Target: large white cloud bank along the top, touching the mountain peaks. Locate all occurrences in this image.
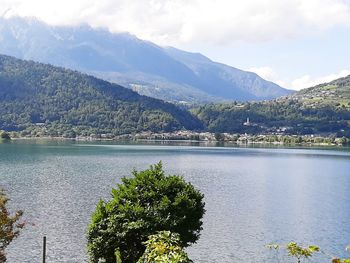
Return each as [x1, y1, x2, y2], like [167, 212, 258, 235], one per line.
[0, 0, 350, 44]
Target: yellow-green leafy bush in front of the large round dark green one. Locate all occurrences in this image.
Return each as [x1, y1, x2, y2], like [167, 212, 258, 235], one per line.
[138, 231, 192, 263]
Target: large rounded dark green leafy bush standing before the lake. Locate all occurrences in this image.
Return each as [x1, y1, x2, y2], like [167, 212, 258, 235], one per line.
[88, 162, 205, 263]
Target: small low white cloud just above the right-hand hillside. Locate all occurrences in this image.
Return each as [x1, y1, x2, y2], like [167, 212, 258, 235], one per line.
[291, 69, 350, 90]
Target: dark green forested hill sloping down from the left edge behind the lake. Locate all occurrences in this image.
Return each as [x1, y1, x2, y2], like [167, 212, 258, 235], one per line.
[0, 55, 202, 137]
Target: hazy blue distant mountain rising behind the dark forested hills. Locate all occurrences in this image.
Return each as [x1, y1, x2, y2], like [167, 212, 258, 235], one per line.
[0, 17, 291, 104]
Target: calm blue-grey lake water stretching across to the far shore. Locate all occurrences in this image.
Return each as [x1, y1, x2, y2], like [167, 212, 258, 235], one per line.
[0, 141, 350, 263]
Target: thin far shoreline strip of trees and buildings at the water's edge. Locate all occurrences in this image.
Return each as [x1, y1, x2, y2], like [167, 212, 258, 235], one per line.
[6, 131, 350, 147]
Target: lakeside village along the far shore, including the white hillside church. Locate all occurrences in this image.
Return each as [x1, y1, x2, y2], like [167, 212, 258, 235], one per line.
[0, 118, 350, 146]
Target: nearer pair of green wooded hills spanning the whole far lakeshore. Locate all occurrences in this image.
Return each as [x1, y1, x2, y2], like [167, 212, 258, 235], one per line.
[0, 52, 350, 137]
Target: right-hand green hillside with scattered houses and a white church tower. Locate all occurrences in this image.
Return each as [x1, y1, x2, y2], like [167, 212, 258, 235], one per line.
[192, 76, 350, 137]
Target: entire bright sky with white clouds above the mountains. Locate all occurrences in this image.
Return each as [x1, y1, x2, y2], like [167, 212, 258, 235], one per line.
[0, 0, 350, 90]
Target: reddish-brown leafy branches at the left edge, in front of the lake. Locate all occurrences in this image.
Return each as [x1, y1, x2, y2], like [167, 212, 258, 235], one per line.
[0, 189, 24, 262]
